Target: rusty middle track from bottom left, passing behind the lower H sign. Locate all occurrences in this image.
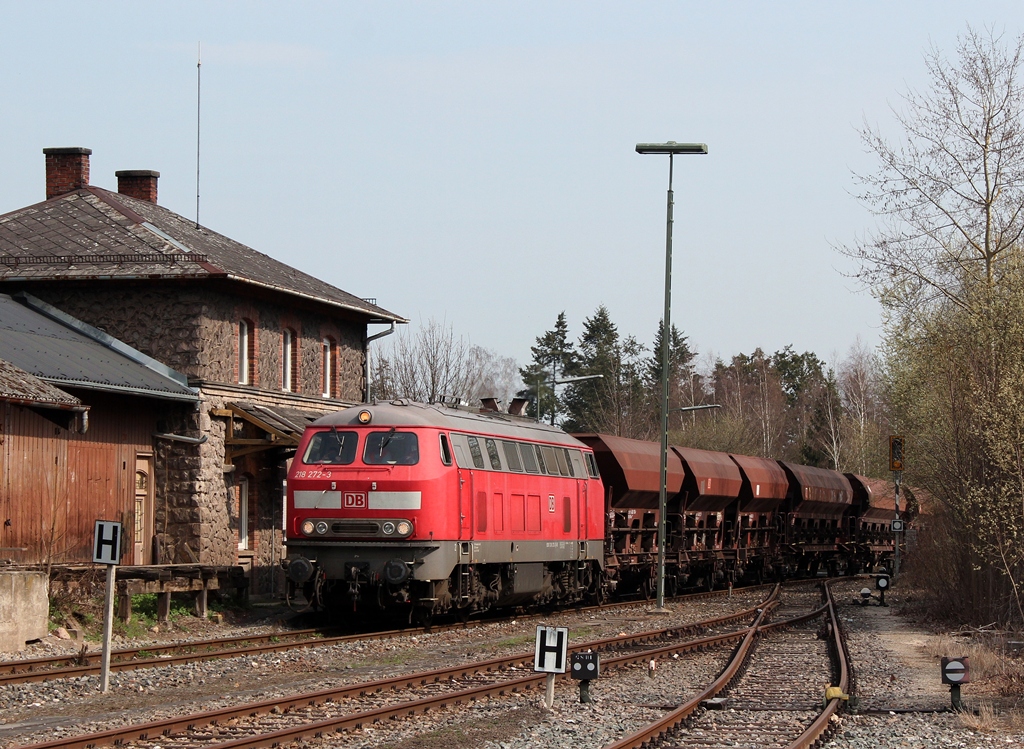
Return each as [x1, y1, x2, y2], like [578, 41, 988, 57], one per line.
[9, 587, 778, 749]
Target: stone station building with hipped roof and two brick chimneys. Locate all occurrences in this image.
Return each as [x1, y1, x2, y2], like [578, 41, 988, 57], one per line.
[0, 148, 407, 593]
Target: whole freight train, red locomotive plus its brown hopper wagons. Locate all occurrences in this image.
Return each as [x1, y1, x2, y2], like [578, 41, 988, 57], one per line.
[283, 400, 894, 622]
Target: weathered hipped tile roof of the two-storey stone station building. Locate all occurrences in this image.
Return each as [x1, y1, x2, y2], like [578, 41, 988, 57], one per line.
[0, 186, 406, 322]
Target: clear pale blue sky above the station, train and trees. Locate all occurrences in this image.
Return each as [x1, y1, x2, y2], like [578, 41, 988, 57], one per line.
[0, 0, 1024, 370]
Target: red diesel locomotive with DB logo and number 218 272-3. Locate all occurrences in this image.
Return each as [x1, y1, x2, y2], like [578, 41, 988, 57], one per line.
[286, 401, 604, 621]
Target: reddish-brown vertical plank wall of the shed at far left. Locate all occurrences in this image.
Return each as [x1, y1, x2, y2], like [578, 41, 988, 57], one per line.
[0, 390, 157, 565]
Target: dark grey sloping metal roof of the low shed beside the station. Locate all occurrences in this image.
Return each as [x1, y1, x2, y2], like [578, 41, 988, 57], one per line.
[0, 294, 199, 401]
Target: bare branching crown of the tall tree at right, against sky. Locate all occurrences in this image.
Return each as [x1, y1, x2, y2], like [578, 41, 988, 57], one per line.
[840, 28, 1024, 317]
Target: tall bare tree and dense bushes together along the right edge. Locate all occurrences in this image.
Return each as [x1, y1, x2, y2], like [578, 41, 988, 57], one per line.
[844, 28, 1024, 627]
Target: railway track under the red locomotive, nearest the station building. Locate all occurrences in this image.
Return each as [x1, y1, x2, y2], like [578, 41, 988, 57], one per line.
[0, 586, 770, 686]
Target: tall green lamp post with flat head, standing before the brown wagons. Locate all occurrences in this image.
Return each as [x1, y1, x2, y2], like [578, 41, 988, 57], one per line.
[637, 140, 708, 609]
